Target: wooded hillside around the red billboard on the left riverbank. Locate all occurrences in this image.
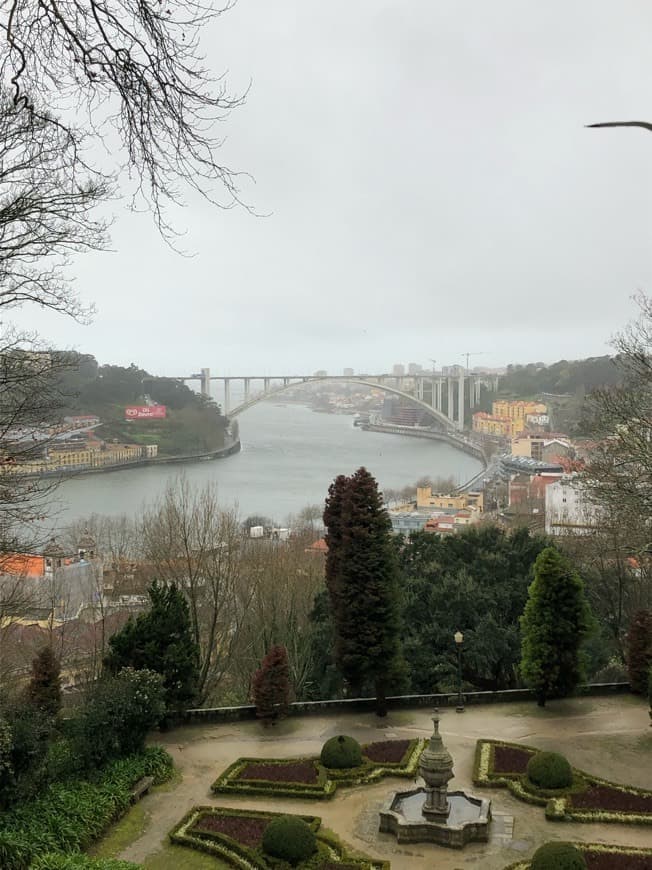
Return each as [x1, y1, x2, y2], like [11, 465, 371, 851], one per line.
[58, 354, 227, 456]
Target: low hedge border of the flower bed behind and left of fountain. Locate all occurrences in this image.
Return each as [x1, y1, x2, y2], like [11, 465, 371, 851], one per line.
[211, 738, 427, 800]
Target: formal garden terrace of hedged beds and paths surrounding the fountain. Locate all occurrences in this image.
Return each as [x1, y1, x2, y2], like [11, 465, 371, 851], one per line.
[62, 695, 652, 870]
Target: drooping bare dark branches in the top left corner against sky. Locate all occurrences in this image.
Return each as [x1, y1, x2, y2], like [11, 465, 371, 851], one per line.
[0, 0, 243, 227]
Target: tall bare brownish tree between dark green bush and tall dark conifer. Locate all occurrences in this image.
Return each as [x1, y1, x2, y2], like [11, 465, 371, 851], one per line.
[140, 477, 254, 703]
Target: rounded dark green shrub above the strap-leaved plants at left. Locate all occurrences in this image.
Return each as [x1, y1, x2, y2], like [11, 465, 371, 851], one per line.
[70, 668, 165, 770]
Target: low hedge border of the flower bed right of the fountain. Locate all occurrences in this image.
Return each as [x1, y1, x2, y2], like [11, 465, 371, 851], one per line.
[473, 740, 652, 828]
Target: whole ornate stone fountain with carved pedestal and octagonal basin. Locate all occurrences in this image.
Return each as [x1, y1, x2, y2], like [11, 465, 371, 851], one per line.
[380, 710, 491, 849]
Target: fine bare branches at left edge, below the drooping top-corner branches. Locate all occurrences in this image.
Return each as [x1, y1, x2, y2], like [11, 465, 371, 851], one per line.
[0, 93, 111, 319]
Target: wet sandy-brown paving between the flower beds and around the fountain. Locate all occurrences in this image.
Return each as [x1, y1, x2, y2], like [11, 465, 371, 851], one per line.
[119, 696, 652, 870]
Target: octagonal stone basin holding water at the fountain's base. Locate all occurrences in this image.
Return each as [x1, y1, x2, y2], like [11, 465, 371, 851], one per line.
[380, 788, 491, 849]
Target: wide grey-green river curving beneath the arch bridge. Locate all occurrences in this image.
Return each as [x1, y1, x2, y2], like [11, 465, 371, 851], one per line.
[49, 401, 481, 527]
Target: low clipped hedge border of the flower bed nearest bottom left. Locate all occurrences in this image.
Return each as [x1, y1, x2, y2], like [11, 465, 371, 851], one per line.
[168, 806, 390, 870]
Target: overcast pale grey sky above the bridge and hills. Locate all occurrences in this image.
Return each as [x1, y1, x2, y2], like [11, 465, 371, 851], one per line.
[17, 0, 652, 374]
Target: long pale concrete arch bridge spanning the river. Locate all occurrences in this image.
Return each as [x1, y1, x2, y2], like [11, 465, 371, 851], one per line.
[169, 366, 495, 432]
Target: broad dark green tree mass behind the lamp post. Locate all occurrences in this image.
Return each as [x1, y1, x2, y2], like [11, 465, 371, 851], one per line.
[399, 525, 547, 693]
